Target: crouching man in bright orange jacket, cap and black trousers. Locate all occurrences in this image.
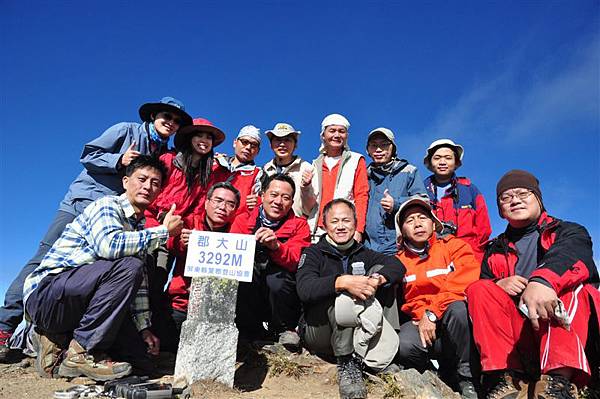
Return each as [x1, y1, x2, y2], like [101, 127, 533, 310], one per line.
[396, 197, 480, 399]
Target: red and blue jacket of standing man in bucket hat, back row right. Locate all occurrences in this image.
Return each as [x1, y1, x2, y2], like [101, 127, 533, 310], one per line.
[424, 175, 492, 261]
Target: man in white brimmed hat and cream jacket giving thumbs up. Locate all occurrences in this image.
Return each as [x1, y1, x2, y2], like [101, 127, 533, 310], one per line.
[263, 123, 319, 216]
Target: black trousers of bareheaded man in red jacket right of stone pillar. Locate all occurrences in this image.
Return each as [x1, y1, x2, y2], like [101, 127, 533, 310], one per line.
[235, 265, 301, 334]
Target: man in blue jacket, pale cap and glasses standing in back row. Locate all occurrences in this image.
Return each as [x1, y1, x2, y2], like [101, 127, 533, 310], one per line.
[365, 127, 427, 255]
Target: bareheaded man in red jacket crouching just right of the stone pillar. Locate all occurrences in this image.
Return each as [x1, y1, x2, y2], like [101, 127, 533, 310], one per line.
[231, 174, 310, 350]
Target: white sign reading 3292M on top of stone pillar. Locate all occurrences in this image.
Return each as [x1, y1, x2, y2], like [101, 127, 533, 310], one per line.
[184, 230, 256, 282]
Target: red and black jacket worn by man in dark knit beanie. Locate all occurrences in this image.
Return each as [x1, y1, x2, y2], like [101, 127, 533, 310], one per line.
[481, 212, 598, 296]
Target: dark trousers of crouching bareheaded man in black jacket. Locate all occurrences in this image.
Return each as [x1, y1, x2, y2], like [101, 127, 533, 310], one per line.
[300, 298, 354, 357]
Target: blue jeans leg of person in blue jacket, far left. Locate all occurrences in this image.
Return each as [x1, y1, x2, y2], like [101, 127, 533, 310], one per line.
[0, 211, 75, 333]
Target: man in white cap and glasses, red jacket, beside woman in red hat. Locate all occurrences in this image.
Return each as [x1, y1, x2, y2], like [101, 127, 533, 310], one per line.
[217, 125, 262, 215]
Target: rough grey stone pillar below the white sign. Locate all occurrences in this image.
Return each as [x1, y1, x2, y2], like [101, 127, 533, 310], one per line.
[175, 277, 238, 387]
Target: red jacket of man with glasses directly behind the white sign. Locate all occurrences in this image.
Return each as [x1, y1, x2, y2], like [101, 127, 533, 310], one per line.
[167, 212, 230, 312]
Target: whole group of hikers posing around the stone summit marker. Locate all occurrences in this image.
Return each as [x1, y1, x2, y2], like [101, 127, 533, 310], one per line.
[0, 97, 600, 398]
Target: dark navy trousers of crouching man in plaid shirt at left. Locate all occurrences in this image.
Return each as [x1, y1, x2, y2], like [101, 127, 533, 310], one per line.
[26, 257, 145, 352]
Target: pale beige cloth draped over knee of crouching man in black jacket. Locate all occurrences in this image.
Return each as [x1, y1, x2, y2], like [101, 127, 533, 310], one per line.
[335, 293, 400, 370]
